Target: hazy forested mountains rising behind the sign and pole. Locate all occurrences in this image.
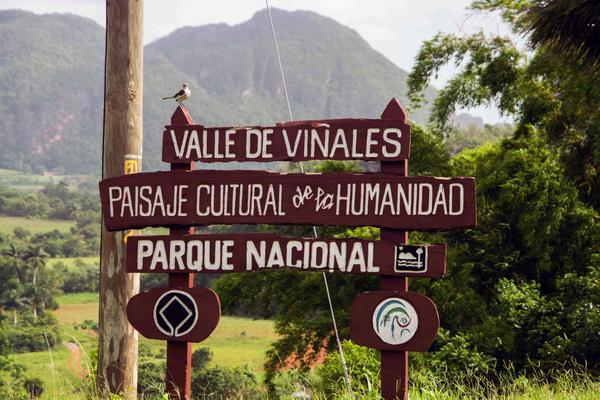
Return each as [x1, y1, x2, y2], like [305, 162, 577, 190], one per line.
[0, 10, 434, 173]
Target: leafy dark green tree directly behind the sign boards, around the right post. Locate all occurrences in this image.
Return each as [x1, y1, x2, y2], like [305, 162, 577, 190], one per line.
[215, 124, 450, 382]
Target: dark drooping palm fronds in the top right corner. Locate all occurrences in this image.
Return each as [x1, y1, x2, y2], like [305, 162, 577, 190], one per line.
[522, 0, 600, 66]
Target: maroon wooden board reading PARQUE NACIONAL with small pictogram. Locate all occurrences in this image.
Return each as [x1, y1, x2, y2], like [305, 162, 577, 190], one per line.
[125, 233, 446, 278]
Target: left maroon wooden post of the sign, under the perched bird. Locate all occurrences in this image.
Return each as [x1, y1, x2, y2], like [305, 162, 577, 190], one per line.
[165, 106, 195, 400]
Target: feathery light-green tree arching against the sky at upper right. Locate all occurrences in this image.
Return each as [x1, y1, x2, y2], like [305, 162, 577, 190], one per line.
[408, 0, 600, 209]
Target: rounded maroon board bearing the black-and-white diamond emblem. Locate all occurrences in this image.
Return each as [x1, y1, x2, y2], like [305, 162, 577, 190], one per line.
[127, 288, 221, 342]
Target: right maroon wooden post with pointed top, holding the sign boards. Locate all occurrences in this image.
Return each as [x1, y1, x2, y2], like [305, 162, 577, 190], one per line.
[380, 99, 408, 400]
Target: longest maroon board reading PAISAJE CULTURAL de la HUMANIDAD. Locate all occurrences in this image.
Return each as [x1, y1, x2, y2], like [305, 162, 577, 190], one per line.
[100, 171, 476, 231]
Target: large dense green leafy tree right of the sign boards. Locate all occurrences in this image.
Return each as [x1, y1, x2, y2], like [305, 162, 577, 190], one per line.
[436, 129, 600, 371]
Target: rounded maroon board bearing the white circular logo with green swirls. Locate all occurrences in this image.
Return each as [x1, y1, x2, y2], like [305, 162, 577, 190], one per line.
[350, 291, 440, 351]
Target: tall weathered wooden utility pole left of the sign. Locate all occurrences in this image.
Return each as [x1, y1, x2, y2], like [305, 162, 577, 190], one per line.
[98, 0, 144, 399]
